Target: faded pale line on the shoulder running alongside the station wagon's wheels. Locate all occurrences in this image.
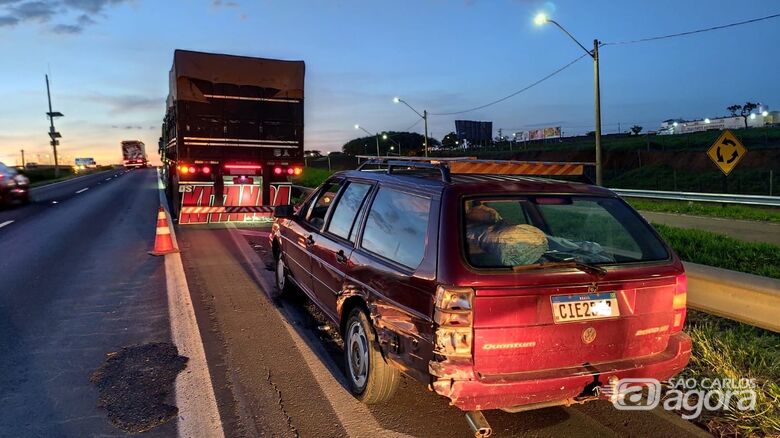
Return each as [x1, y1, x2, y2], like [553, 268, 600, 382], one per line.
[225, 223, 411, 438]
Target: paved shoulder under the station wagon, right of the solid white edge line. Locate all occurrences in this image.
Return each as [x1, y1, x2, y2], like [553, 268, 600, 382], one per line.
[178, 226, 706, 437]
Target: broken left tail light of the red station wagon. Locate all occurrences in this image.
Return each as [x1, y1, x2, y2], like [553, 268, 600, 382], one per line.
[433, 286, 474, 357]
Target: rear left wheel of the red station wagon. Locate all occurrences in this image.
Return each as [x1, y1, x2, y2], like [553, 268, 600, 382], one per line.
[344, 308, 401, 404]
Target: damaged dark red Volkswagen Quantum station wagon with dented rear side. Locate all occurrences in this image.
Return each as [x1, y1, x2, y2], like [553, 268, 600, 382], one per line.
[270, 158, 691, 436]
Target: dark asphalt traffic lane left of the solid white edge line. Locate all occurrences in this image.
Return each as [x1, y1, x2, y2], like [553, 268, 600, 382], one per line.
[0, 169, 176, 437]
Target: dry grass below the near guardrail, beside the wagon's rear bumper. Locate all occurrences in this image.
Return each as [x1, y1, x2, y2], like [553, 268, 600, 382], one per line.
[680, 310, 780, 436]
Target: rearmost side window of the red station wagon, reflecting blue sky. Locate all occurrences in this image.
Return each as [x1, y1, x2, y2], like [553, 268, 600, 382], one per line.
[361, 187, 431, 269]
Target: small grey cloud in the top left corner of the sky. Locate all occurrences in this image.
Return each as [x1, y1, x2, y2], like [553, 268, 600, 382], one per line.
[0, 0, 130, 35]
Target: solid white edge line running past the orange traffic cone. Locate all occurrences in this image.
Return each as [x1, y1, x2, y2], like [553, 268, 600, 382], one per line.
[159, 169, 225, 438]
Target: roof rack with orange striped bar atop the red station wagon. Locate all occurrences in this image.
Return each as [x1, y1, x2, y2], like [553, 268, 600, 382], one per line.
[357, 155, 595, 183]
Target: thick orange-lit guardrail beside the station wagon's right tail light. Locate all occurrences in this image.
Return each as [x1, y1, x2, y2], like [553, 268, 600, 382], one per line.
[685, 262, 780, 332]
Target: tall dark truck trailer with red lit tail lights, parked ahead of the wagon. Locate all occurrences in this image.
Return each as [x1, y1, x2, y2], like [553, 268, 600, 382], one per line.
[159, 50, 305, 224]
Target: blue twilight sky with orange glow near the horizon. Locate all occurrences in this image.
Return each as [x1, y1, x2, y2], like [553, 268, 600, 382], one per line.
[0, 0, 780, 164]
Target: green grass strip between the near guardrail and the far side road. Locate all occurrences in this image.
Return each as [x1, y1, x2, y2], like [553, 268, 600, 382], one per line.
[653, 224, 780, 279]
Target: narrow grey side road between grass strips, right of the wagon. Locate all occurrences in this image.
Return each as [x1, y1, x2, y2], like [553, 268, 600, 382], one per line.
[640, 211, 780, 245]
